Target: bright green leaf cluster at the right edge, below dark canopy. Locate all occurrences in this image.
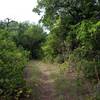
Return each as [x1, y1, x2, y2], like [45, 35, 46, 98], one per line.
[76, 20, 100, 50]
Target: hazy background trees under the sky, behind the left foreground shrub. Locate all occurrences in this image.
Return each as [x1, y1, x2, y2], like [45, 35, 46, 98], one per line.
[0, 19, 46, 58]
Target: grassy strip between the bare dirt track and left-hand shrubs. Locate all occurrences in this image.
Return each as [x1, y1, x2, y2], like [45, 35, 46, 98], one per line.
[24, 60, 41, 100]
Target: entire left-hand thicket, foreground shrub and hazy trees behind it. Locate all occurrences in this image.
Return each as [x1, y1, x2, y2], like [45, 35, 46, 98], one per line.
[0, 19, 46, 100]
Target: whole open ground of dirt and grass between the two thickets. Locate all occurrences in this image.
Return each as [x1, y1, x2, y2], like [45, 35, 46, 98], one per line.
[24, 61, 89, 100]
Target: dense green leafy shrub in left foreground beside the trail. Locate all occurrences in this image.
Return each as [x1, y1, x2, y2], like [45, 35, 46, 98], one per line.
[0, 36, 28, 100]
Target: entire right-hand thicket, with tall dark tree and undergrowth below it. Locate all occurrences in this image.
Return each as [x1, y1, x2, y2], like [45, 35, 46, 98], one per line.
[33, 0, 100, 100]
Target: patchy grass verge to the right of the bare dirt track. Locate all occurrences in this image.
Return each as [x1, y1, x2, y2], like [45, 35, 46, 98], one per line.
[54, 63, 97, 100]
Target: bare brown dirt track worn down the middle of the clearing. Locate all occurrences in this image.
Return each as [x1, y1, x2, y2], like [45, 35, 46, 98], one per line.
[36, 62, 59, 100]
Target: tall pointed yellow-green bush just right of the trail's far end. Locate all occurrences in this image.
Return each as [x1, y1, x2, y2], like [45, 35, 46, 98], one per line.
[42, 18, 66, 63]
